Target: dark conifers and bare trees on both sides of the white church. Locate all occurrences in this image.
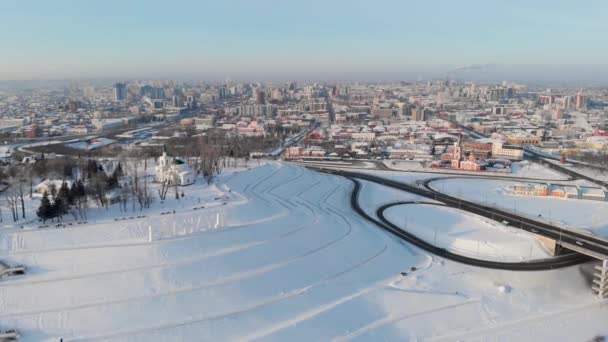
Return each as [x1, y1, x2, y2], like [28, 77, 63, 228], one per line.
[7, 131, 268, 221]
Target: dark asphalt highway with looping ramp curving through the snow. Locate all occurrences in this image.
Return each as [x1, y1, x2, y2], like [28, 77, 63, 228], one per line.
[307, 159, 608, 271]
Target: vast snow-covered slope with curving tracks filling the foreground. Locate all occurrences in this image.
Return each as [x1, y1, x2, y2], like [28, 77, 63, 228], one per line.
[0, 163, 608, 341]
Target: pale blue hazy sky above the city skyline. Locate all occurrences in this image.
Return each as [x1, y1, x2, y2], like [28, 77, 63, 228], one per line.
[0, 0, 608, 79]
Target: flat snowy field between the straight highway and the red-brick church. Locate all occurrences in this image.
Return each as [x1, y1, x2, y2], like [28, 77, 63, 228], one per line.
[430, 178, 608, 236]
